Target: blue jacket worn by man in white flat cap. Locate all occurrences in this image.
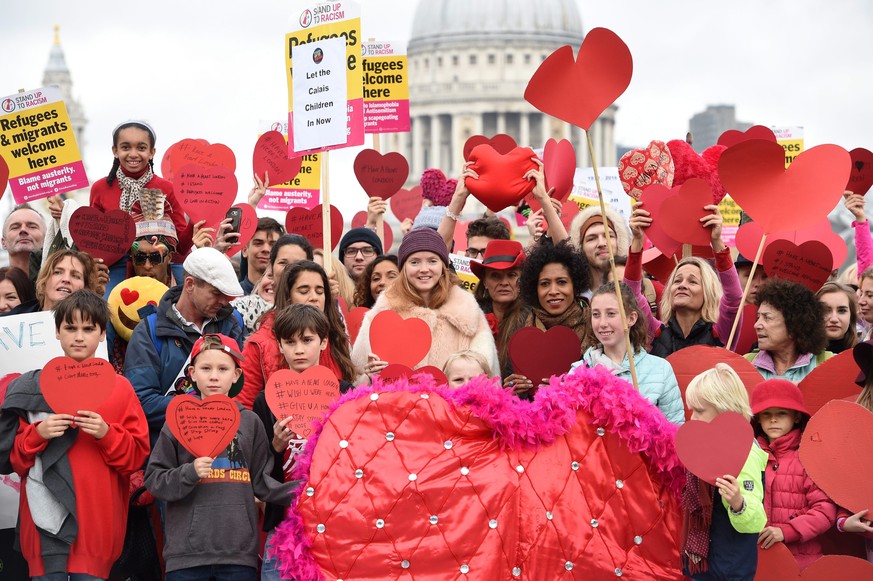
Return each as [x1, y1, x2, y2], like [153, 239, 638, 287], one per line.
[124, 286, 243, 448]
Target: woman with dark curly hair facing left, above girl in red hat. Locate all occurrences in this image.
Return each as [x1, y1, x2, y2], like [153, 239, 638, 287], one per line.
[744, 278, 833, 383]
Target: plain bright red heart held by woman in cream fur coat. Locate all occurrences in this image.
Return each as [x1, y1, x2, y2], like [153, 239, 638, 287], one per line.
[370, 311, 431, 368]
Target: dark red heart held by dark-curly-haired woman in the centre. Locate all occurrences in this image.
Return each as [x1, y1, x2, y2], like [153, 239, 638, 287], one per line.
[509, 325, 582, 388]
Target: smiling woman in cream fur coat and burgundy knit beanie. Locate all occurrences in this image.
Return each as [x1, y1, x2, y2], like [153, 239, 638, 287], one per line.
[352, 228, 500, 380]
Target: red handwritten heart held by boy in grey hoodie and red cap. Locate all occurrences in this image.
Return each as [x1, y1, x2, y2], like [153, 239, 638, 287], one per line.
[167, 395, 239, 458]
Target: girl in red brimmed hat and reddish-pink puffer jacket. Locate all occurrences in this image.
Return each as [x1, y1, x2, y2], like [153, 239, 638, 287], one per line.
[751, 379, 837, 569]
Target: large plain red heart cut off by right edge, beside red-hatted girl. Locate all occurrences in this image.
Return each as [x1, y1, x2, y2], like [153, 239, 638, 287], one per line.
[800, 400, 873, 513]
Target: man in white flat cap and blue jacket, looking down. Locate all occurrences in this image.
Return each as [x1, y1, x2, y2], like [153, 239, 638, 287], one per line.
[124, 247, 244, 446]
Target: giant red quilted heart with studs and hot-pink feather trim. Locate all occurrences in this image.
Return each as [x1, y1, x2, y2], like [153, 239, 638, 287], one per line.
[273, 369, 684, 581]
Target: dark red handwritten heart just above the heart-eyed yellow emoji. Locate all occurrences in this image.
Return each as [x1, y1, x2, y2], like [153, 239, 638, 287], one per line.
[69, 206, 136, 266]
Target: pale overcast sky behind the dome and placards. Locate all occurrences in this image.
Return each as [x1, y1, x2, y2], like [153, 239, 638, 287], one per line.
[0, 0, 873, 218]
